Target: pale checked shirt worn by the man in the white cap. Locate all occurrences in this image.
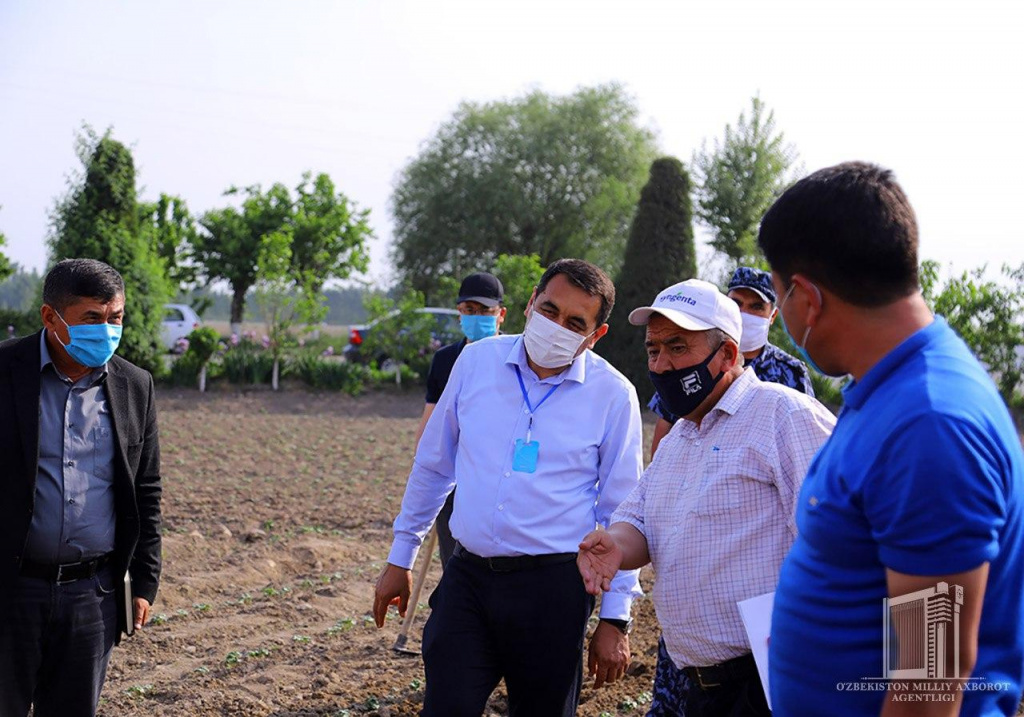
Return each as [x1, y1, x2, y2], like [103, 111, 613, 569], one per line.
[612, 369, 836, 668]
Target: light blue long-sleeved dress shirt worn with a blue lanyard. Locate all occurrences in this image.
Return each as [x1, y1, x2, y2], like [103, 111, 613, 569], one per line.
[388, 336, 643, 619]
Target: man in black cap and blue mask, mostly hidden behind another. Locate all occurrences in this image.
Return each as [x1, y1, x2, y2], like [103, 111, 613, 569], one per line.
[416, 271, 506, 568]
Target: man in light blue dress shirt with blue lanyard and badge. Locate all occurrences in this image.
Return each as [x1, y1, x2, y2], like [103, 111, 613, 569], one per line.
[374, 259, 642, 717]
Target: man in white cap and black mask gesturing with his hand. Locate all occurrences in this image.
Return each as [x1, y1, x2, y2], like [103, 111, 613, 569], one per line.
[578, 280, 836, 717]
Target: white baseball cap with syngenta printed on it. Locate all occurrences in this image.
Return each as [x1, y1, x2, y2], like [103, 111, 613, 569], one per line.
[630, 279, 743, 343]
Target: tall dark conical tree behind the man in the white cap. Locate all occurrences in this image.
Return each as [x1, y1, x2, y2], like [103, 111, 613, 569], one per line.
[598, 157, 696, 398]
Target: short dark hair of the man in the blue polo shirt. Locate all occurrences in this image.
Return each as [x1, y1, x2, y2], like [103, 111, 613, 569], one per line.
[758, 162, 919, 306]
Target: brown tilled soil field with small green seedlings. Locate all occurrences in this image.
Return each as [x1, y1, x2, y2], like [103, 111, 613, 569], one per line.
[100, 389, 657, 717]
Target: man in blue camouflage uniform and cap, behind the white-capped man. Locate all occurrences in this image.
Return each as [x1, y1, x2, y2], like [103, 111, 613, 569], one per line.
[647, 266, 814, 717]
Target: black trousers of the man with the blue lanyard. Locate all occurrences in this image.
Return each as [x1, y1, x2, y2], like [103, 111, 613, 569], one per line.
[422, 556, 594, 717]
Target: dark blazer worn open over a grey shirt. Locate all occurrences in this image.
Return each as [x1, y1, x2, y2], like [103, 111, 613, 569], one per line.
[0, 333, 161, 603]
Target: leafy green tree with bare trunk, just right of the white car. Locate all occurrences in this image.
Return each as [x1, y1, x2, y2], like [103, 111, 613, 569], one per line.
[193, 183, 292, 333]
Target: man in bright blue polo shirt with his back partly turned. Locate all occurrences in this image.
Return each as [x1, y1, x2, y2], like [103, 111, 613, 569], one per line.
[758, 163, 1024, 715]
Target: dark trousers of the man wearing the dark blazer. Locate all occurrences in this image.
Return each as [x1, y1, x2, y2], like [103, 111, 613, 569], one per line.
[0, 565, 118, 717]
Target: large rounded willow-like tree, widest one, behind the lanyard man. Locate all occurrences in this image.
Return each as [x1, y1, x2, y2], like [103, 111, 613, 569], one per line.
[391, 85, 655, 299]
